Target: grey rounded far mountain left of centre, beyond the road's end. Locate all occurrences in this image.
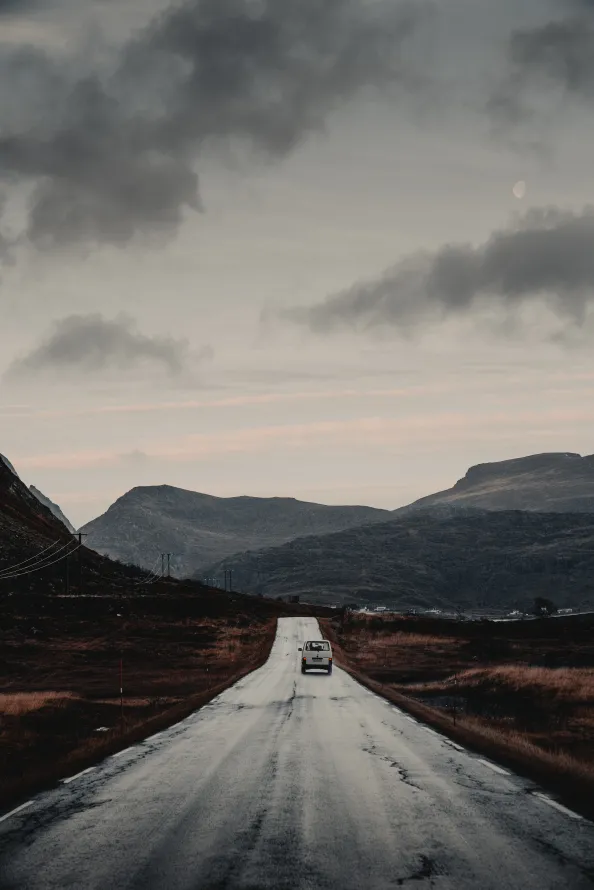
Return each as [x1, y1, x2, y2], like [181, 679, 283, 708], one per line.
[81, 485, 391, 577]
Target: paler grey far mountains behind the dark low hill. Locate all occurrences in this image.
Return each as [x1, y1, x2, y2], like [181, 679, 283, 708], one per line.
[81, 453, 594, 577]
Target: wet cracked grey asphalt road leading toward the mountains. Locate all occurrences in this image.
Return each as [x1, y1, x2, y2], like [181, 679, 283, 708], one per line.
[0, 618, 594, 890]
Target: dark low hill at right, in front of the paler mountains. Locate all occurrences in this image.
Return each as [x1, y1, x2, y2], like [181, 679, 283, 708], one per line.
[204, 507, 594, 609]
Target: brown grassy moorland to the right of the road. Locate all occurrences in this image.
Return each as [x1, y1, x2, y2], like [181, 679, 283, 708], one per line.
[320, 616, 594, 818]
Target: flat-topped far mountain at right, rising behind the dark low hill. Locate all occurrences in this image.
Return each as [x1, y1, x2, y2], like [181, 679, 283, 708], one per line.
[394, 452, 594, 515]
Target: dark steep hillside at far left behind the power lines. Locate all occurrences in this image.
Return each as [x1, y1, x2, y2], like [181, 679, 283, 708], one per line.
[0, 455, 332, 612]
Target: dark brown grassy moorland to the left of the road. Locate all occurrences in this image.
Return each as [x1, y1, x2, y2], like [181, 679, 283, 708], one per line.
[0, 595, 300, 808]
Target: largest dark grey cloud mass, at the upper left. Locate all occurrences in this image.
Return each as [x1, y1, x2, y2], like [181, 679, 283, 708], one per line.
[0, 0, 424, 248]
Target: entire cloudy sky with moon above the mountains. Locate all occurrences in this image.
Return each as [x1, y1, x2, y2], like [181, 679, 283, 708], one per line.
[0, 0, 594, 526]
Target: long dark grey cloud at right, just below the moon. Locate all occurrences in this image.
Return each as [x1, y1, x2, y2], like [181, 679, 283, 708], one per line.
[288, 208, 594, 331]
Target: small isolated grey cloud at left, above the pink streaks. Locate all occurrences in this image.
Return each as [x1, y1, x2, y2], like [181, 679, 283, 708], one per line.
[6, 314, 188, 379]
